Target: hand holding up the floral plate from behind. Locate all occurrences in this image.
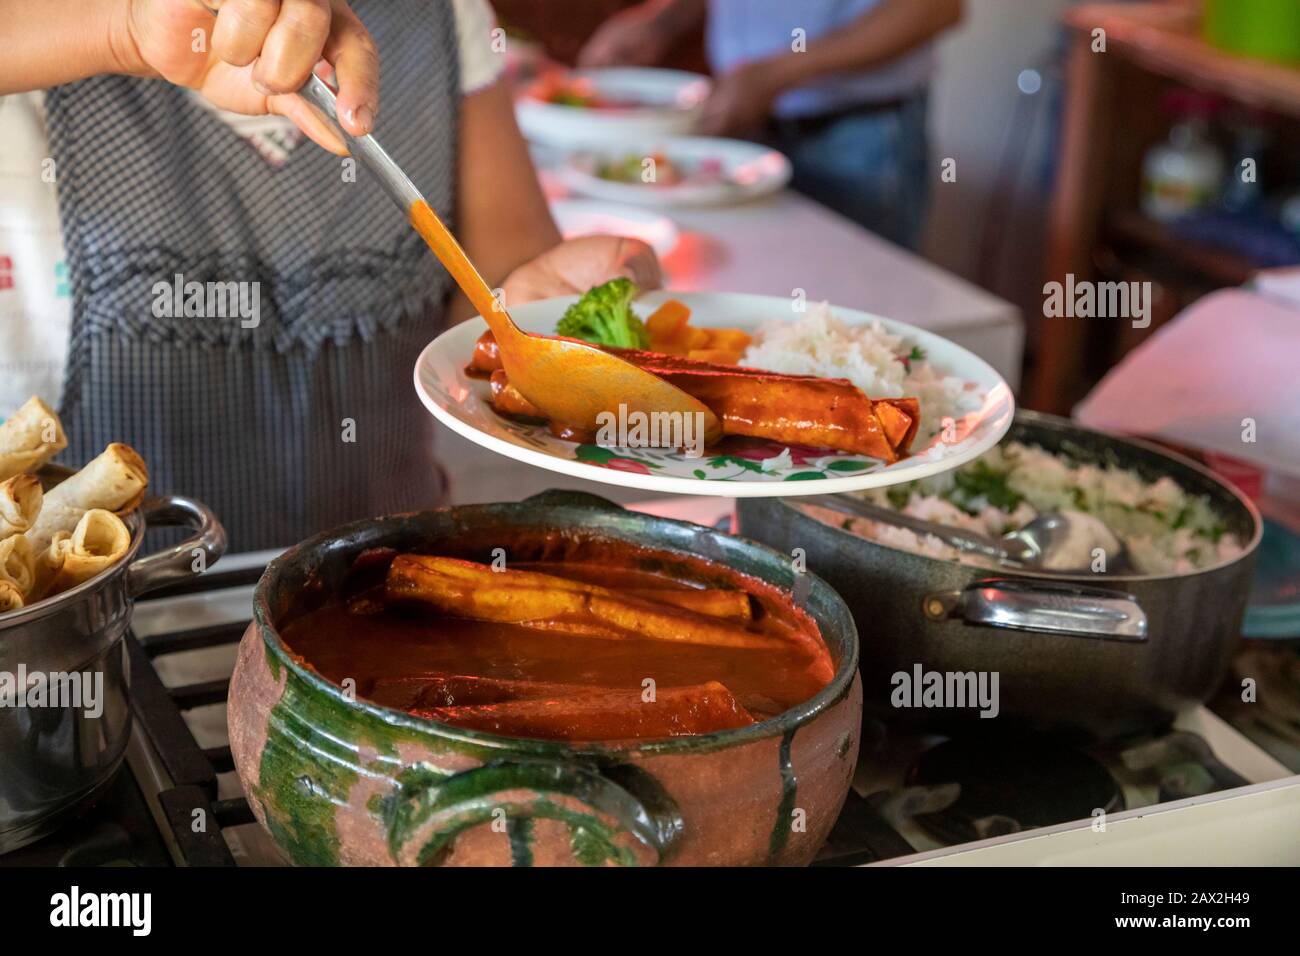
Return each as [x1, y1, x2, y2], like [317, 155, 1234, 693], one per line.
[504, 235, 663, 308]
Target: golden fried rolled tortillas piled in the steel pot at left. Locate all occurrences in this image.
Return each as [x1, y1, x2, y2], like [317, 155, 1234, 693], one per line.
[0, 398, 148, 613]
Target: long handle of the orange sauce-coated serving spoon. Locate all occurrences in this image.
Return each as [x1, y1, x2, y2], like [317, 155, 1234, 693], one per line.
[299, 73, 501, 325]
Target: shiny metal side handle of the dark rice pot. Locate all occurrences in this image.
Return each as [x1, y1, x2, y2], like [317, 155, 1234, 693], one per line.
[923, 580, 1147, 641]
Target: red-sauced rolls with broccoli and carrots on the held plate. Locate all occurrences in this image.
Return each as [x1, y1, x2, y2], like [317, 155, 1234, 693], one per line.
[467, 280, 922, 463]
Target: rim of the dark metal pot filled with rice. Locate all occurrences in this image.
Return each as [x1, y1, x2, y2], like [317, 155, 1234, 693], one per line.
[779, 410, 1264, 585]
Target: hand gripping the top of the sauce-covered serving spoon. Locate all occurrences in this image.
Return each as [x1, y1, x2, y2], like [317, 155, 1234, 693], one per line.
[113, 0, 380, 155]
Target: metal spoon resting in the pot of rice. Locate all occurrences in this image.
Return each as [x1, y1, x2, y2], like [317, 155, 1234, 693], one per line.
[816, 494, 1136, 574]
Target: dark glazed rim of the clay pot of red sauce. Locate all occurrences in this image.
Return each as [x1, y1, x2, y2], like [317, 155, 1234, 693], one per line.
[252, 501, 859, 760]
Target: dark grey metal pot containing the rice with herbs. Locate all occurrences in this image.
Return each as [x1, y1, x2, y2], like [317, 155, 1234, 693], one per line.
[737, 411, 1262, 734]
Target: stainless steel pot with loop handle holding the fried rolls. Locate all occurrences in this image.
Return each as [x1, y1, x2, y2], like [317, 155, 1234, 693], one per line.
[0, 496, 226, 853]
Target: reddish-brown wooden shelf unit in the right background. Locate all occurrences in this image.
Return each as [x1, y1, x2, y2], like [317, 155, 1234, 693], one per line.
[1022, 3, 1300, 412]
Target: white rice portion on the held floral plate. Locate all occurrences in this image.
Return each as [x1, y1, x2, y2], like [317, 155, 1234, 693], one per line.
[740, 303, 983, 449]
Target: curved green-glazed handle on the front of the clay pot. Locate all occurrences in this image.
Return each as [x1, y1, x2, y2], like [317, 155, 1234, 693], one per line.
[384, 760, 683, 866]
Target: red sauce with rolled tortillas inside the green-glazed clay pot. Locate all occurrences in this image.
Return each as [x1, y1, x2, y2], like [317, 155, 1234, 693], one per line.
[283, 540, 833, 741]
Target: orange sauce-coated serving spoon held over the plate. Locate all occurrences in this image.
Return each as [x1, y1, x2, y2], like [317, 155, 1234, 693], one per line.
[299, 73, 722, 444]
